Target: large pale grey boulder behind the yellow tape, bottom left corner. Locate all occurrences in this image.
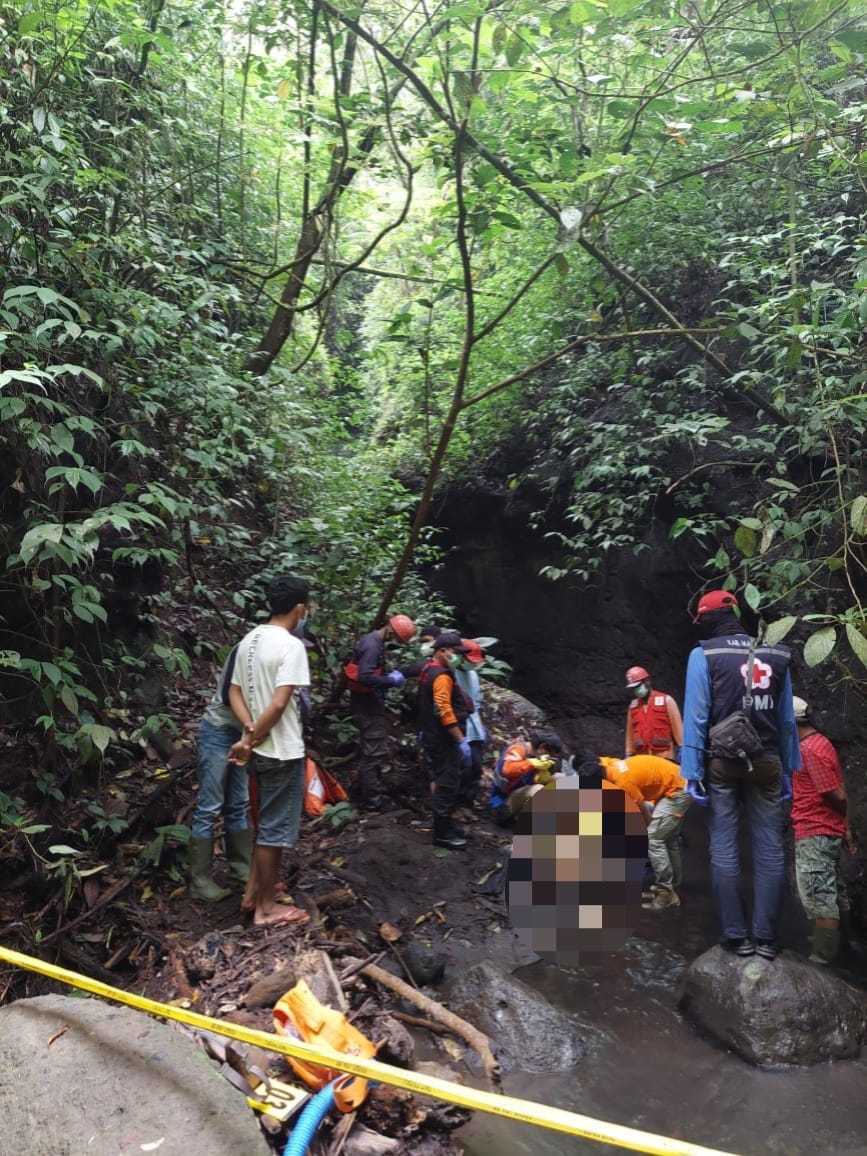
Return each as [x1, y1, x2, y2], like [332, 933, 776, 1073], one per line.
[0, 995, 269, 1156]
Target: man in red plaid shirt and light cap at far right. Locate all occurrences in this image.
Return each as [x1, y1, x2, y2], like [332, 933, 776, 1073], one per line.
[792, 697, 850, 964]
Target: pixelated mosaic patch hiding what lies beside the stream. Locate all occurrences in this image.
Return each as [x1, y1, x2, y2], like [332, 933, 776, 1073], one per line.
[509, 776, 647, 965]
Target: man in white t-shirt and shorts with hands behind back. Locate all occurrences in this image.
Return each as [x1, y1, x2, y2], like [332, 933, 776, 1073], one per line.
[229, 575, 310, 926]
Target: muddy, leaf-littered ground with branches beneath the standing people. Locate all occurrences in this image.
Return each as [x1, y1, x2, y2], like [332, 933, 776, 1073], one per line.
[0, 688, 545, 1156]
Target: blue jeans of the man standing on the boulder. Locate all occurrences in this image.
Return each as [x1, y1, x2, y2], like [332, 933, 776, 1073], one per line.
[707, 753, 786, 940]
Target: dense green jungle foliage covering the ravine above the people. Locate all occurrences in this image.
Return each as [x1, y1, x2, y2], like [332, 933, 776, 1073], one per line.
[0, 0, 867, 799]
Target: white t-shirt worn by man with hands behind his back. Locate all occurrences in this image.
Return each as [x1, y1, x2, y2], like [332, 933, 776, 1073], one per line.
[232, 625, 310, 759]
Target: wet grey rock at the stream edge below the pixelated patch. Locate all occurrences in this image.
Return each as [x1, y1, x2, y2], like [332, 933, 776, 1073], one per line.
[449, 963, 586, 1072]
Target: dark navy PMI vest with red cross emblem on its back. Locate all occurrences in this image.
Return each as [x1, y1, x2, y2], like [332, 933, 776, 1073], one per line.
[701, 633, 792, 750]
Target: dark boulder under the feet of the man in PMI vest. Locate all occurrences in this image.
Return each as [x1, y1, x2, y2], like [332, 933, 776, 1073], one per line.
[680, 947, 867, 1067]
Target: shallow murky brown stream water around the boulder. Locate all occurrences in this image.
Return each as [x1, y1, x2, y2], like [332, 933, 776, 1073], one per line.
[460, 812, 867, 1156]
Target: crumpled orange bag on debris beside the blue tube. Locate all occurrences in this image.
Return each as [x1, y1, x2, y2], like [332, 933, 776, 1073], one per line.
[273, 979, 377, 1112]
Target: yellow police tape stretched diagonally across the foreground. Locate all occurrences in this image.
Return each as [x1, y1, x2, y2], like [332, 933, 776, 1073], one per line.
[0, 947, 732, 1156]
